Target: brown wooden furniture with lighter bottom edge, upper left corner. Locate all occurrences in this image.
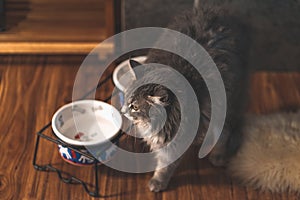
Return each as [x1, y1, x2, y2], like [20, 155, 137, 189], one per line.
[0, 0, 113, 55]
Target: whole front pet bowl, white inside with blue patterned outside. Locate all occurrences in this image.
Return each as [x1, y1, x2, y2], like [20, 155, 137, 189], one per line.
[52, 100, 122, 165]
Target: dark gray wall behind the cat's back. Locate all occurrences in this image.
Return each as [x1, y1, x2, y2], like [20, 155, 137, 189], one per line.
[120, 0, 300, 71]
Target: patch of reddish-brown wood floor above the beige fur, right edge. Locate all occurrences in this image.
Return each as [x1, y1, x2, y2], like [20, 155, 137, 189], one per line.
[249, 72, 300, 114]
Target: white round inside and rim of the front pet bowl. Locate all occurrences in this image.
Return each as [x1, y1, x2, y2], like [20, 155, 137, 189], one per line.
[52, 100, 122, 146]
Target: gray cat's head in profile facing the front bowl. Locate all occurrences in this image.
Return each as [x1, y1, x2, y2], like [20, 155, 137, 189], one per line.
[121, 60, 175, 137]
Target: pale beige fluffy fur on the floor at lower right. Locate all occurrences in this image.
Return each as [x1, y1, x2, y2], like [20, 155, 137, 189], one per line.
[228, 111, 300, 192]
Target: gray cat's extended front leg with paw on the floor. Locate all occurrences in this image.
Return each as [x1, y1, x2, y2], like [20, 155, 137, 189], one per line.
[148, 154, 181, 192]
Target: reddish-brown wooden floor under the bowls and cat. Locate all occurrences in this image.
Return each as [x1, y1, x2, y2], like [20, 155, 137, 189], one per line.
[0, 56, 300, 200]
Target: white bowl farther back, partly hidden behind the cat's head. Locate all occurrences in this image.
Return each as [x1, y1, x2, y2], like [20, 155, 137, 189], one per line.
[112, 56, 147, 108]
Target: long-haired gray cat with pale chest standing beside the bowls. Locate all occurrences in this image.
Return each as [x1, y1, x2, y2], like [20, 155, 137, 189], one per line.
[122, 8, 249, 192]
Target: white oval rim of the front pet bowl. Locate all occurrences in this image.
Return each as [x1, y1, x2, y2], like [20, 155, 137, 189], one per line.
[51, 100, 123, 146]
